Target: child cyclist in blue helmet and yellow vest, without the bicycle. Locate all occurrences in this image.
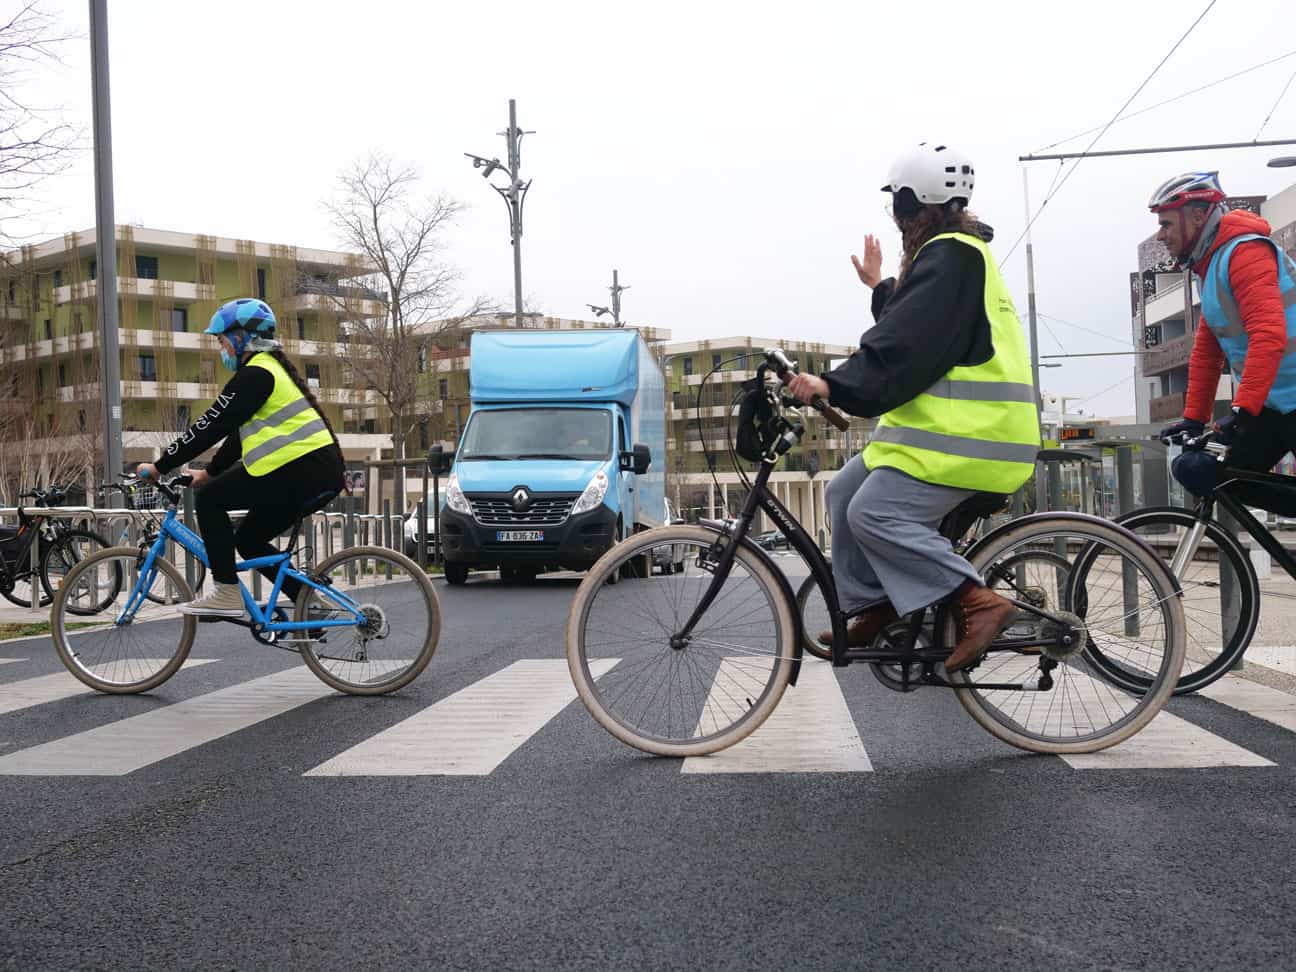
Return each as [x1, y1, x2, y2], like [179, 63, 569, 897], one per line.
[137, 298, 343, 618]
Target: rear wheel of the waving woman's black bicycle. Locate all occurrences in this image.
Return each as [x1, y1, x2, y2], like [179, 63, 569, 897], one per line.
[942, 513, 1186, 754]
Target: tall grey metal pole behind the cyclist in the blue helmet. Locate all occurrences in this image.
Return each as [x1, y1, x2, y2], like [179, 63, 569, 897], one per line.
[89, 0, 122, 487]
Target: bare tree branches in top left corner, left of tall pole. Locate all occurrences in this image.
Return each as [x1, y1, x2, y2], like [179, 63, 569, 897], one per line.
[0, 3, 79, 245]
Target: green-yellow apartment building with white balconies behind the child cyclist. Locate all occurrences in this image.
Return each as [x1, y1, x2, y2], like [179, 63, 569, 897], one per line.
[0, 226, 390, 481]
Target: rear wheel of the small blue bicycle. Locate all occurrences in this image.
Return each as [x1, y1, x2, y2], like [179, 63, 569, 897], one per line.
[294, 547, 441, 695]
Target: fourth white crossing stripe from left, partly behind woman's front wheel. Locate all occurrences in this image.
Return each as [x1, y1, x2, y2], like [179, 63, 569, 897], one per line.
[680, 658, 874, 774]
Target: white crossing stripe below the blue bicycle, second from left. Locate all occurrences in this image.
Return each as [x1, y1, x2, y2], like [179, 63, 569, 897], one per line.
[0, 666, 333, 776]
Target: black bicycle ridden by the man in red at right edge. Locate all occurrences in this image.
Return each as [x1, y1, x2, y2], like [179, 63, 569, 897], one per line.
[1107, 432, 1296, 695]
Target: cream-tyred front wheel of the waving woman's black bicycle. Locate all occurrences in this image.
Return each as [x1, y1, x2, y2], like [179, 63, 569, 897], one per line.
[566, 526, 796, 757]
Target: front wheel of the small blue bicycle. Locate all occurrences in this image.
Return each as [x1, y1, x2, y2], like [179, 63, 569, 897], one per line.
[49, 547, 198, 695]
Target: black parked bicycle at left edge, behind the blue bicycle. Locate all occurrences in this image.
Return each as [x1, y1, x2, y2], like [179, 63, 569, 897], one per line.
[0, 486, 109, 614]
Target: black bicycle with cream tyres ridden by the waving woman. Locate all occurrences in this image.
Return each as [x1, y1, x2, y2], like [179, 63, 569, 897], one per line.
[566, 350, 1186, 757]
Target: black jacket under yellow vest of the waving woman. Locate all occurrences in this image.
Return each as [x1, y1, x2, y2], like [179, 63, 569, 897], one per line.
[820, 240, 994, 417]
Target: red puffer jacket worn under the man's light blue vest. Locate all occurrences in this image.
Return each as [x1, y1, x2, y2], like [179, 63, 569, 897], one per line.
[1183, 210, 1287, 422]
